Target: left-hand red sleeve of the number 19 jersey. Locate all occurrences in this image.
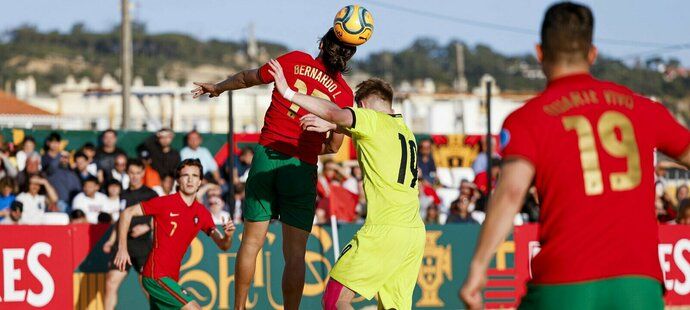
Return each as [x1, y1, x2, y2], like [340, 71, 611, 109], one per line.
[500, 109, 537, 165]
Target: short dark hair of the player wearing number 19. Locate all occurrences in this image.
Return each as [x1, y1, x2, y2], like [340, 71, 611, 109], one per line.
[541, 2, 594, 62]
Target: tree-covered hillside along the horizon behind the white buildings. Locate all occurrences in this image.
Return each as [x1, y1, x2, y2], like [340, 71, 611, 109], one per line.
[0, 24, 690, 118]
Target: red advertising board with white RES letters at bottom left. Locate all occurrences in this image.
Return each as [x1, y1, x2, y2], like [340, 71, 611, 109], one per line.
[0, 225, 74, 309]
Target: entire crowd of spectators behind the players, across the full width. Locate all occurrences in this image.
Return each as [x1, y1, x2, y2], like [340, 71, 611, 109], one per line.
[0, 129, 690, 225]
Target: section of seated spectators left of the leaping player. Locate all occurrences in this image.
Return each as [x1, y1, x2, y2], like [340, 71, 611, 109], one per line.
[0, 129, 253, 228]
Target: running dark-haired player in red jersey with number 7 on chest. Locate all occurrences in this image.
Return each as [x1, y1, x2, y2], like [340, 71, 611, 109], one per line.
[115, 159, 235, 309]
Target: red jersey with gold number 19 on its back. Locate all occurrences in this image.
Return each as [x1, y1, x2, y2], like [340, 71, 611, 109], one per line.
[501, 74, 690, 284]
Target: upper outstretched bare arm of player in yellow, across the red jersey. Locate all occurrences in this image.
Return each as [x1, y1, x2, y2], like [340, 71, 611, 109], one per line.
[268, 59, 352, 127]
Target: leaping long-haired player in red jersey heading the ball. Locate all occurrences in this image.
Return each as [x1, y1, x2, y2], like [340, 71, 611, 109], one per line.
[192, 29, 356, 309]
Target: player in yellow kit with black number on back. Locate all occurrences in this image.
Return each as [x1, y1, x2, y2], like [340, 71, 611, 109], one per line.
[269, 60, 426, 310]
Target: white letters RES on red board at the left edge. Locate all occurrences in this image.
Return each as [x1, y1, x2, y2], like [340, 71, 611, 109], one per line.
[0, 242, 55, 307]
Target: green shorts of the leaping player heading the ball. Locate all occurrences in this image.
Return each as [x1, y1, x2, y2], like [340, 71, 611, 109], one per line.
[242, 145, 316, 232]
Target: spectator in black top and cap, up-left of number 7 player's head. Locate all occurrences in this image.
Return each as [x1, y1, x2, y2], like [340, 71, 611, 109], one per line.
[141, 128, 180, 178]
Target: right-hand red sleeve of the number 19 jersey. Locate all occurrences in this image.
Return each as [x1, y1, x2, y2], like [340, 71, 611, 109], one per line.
[653, 103, 690, 158]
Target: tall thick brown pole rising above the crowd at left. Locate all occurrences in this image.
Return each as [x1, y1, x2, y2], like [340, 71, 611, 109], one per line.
[120, 0, 132, 130]
